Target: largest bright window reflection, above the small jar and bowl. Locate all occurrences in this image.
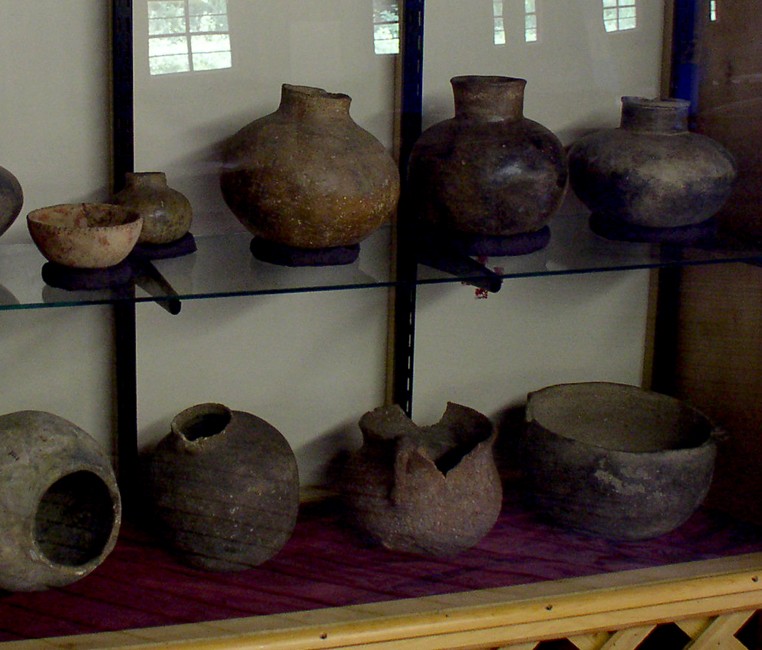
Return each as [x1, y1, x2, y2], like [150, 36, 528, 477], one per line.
[148, 0, 232, 75]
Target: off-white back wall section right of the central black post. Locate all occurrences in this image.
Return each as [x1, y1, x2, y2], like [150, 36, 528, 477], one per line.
[406, 0, 664, 422]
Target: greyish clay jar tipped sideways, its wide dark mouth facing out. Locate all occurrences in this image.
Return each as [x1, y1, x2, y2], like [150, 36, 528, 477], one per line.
[0, 411, 122, 591]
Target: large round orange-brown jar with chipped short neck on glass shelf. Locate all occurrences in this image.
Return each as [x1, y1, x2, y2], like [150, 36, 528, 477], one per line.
[220, 84, 399, 249]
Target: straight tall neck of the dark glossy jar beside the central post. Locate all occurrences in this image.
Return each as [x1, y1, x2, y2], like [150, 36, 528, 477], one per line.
[450, 75, 527, 121]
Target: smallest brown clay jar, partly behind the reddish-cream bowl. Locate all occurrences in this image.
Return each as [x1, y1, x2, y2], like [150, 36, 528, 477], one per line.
[112, 172, 193, 244]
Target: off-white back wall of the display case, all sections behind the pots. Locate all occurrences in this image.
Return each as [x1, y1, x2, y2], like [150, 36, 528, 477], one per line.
[0, 0, 662, 483]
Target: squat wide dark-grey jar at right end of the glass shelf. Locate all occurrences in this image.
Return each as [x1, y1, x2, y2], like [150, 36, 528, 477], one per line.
[569, 97, 736, 228]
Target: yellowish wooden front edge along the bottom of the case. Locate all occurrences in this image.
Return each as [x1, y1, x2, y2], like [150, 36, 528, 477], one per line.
[3, 553, 762, 650]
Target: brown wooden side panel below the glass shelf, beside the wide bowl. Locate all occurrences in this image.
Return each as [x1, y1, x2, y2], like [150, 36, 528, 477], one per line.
[677, 265, 762, 523]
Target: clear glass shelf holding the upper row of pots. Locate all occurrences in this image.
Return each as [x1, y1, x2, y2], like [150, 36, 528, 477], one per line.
[0, 213, 762, 311]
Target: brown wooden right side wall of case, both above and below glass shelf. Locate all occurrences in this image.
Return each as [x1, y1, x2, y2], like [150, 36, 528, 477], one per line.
[677, 0, 762, 522]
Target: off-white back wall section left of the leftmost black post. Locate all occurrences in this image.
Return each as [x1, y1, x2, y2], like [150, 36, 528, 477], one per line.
[0, 0, 113, 445]
